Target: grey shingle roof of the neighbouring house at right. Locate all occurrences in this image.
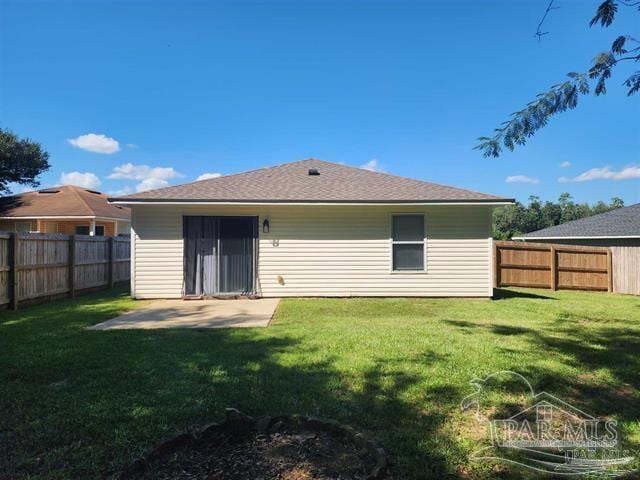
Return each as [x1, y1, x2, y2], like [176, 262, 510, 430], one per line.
[514, 203, 640, 240]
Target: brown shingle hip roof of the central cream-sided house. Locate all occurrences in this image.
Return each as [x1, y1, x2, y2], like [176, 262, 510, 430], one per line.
[110, 159, 512, 203]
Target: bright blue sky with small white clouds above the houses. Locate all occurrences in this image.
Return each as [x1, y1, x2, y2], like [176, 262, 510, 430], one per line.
[0, 0, 640, 204]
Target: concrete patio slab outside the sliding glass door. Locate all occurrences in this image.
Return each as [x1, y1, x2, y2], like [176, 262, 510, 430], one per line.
[89, 298, 280, 330]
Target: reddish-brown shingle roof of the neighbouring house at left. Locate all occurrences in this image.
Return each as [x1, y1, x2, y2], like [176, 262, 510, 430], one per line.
[0, 185, 131, 220]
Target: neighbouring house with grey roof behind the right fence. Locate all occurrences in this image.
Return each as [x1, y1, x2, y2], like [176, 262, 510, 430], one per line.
[513, 203, 640, 247]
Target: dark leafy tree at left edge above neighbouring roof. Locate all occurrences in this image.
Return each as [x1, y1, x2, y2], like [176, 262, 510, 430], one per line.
[0, 128, 49, 195]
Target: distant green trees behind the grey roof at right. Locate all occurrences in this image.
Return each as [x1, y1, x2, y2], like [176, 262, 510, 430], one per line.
[493, 193, 624, 240]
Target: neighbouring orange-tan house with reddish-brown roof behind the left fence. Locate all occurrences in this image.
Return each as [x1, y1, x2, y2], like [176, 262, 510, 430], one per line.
[0, 185, 131, 237]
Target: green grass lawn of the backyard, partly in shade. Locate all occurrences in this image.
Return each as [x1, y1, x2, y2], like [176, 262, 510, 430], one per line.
[0, 290, 640, 479]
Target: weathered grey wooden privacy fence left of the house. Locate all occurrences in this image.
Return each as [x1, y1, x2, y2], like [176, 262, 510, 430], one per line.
[0, 232, 131, 309]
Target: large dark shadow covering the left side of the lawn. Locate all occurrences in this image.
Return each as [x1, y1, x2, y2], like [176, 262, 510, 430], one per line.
[0, 286, 464, 478]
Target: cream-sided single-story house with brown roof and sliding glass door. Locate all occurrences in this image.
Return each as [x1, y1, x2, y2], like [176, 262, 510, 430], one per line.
[110, 159, 512, 298]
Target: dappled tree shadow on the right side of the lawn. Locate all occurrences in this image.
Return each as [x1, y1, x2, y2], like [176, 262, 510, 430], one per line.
[444, 306, 640, 455]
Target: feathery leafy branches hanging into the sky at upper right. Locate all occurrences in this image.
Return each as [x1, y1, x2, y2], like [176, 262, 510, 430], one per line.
[475, 0, 640, 157]
